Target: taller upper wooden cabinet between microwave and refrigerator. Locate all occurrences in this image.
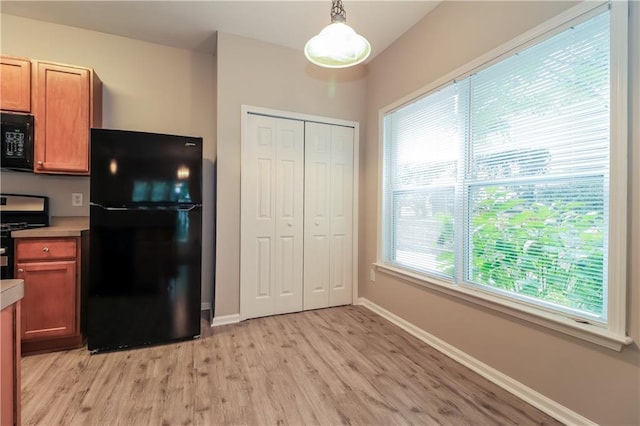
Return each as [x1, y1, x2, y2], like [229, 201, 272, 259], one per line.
[33, 61, 102, 175]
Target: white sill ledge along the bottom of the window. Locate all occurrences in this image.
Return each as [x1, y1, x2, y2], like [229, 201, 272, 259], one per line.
[374, 263, 633, 352]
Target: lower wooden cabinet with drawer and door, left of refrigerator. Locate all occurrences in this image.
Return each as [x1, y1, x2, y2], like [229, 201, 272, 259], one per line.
[15, 237, 83, 354]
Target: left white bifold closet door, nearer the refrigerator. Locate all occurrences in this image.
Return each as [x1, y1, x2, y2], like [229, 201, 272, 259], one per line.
[240, 114, 304, 319]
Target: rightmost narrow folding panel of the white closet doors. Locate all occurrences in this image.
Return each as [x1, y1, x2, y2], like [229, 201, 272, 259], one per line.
[329, 126, 354, 306]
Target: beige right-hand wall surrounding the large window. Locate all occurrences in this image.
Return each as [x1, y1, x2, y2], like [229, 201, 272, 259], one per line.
[359, 1, 640, 425]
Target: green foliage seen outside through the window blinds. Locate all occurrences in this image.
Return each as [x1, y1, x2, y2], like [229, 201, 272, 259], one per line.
[438, 186, 605, 316]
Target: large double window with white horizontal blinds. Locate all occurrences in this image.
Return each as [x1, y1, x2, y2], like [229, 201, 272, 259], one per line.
[379, 1, 626, 348]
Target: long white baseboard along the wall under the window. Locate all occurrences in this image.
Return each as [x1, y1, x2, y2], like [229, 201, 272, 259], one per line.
[358, 297, 596, 426]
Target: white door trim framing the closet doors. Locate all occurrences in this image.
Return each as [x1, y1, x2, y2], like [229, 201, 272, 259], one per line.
[239, 105, 360, 321]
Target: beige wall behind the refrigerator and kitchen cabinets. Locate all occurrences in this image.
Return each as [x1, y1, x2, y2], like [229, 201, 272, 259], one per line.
[0, 15, 216, 303]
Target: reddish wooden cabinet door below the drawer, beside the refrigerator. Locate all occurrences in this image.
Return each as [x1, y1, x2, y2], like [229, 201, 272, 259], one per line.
[16, 261, 78, 341]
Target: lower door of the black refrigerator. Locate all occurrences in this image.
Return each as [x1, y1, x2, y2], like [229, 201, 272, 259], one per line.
[87, 205, 202, 352]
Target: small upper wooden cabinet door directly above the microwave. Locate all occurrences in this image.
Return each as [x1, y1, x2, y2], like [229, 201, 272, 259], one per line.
[0, 56, 31, 113]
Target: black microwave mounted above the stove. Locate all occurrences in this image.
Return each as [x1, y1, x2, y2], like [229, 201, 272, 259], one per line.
[0, 112, 34, 172]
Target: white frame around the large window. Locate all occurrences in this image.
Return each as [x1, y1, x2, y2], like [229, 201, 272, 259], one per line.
[374, 0, 632, 351]
